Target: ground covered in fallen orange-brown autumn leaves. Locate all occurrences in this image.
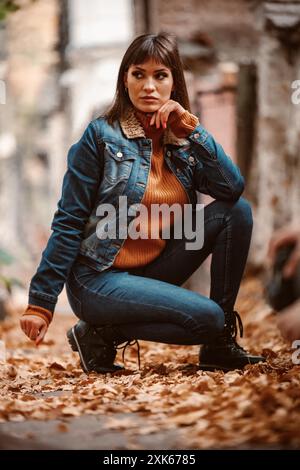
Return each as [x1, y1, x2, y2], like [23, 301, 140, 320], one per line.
[0, 279, 300, 449]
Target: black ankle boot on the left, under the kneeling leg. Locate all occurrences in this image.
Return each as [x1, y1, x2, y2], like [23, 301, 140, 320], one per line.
[67, 320, 127, 374]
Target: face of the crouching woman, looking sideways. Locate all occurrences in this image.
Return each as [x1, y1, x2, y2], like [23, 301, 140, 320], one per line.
[124, 59, 174, 113]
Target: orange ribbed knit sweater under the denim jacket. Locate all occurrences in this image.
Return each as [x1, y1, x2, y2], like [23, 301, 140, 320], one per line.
[113, 111, 198, 269]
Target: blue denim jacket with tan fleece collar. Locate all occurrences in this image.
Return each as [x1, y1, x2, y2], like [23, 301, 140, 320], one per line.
[29, 109, 244, 312]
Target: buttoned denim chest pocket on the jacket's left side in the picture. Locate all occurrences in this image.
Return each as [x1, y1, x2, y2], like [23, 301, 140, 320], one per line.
[103, 144, 136, 185]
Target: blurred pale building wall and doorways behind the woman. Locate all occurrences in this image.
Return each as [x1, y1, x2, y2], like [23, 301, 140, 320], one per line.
[0, 0, 300, 312]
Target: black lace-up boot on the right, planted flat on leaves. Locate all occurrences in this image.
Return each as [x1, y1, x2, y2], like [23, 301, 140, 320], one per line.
[199, 311, 266, 372]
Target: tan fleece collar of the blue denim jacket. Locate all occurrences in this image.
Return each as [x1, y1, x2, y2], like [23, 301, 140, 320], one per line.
[120, 107, 188, 146]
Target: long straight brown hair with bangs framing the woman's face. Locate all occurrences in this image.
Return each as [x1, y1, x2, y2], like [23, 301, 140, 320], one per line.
[104, 33, 190, 125]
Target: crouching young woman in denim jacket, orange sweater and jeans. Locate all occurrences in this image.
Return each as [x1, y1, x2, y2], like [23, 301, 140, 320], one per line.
[21, 34, 264, 373]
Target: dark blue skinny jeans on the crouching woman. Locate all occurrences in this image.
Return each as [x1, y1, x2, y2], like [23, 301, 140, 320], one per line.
[66, 198, 252, 345]
